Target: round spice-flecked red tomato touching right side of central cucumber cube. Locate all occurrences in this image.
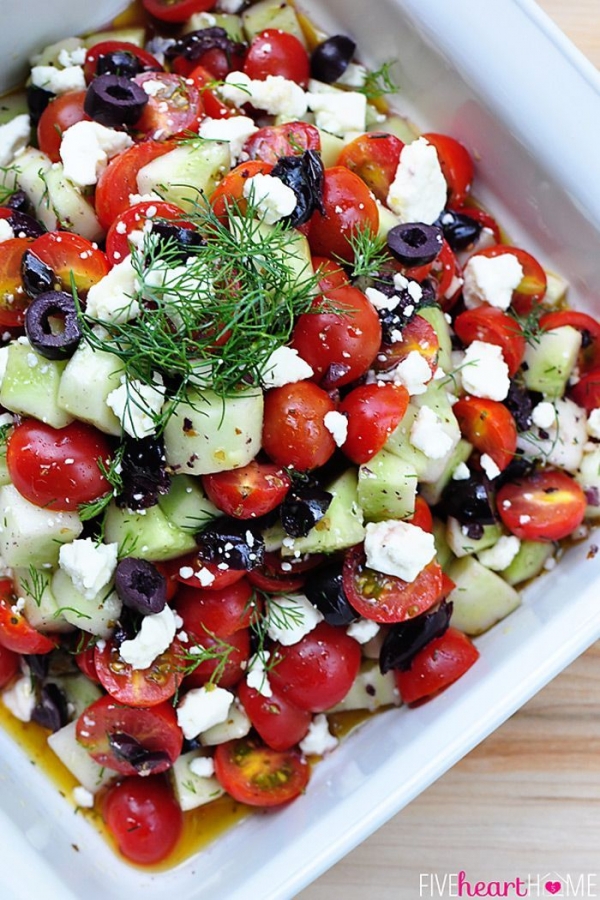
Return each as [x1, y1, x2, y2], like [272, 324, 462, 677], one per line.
[262, 381, 335, 472]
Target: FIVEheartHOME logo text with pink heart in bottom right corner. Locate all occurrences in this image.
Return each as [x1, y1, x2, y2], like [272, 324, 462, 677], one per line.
[419, 871, 600, 900]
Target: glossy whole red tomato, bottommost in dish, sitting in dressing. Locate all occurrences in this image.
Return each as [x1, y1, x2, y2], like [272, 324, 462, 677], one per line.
[102, 776, 183, 866]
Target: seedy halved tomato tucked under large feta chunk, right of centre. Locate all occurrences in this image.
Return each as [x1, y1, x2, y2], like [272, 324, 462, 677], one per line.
[343, 545, 442, 622]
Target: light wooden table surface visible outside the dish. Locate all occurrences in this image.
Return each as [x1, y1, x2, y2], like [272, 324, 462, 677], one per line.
[300, 0, 600, 900]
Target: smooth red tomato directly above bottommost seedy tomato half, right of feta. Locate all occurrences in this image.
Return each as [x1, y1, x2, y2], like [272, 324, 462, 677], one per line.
[237, 680, 312, 750]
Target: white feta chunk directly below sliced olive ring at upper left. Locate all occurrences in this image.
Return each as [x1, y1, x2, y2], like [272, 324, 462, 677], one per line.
[60, 120, 133, 187]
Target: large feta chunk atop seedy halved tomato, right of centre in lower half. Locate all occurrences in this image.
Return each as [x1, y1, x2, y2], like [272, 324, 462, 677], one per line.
[365, 519, 435, 584]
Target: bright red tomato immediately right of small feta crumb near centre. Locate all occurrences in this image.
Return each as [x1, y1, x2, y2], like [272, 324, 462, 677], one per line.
[339, 384, 410, 465]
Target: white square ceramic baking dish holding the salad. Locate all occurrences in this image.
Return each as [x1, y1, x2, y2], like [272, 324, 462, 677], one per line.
[0, 0, 600, 900]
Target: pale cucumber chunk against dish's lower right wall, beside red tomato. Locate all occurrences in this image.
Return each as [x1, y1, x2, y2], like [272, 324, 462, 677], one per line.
[448, 556, 521, 635]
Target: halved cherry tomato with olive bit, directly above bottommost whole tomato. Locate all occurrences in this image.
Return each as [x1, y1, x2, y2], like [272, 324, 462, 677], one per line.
[76, 695, 183, 775]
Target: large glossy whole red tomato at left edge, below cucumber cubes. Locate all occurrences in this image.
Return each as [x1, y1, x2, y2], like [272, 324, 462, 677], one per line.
[6, 419, 112, 511]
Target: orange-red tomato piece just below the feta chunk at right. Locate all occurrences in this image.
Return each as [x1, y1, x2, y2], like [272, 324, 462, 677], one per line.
[452, 397, 517, 471]
